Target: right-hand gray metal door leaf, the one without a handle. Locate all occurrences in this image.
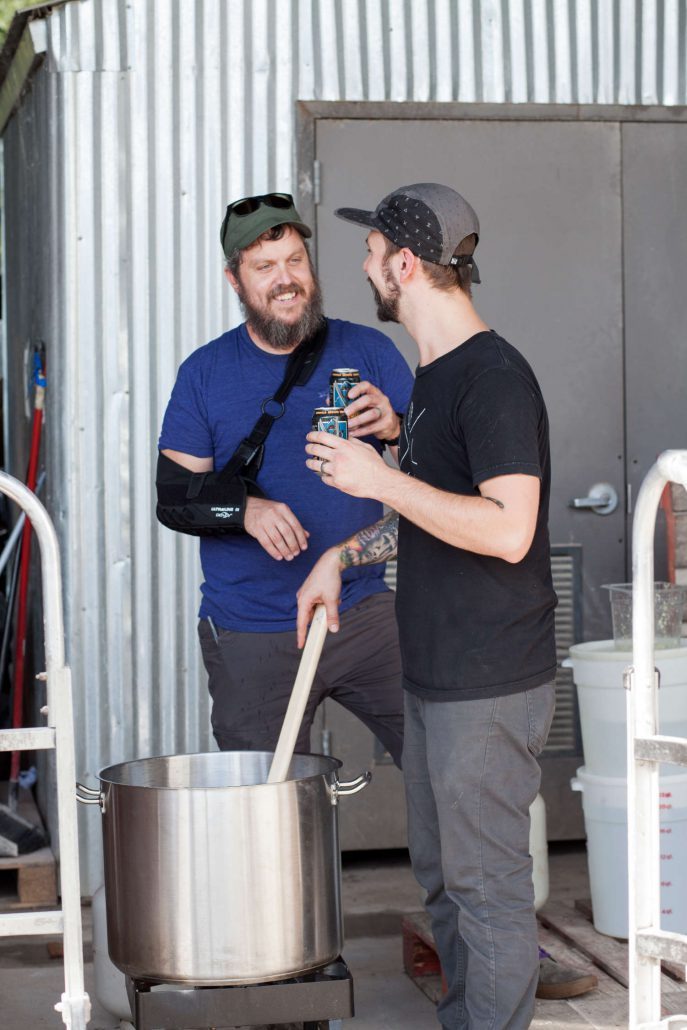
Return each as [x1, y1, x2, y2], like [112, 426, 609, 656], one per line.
[622, 125, 687, 531]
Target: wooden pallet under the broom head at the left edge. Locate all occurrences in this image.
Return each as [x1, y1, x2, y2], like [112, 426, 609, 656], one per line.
[0, 790, 58, 912]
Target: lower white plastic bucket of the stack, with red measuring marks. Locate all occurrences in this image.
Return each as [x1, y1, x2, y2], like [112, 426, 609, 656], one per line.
[571, 766, 687, 937]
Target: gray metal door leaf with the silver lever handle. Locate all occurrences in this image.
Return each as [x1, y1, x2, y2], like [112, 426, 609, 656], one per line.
[316, 121, 625, 640]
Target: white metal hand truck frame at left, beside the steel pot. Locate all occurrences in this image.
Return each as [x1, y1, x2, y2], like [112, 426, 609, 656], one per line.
[0, 473, 91, 1030]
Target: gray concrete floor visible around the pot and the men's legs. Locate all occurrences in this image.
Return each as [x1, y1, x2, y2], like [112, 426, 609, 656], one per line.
[0, 846, 588, 1030]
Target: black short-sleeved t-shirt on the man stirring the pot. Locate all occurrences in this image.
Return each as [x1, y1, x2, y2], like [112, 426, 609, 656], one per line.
[397, 332, 556, 700]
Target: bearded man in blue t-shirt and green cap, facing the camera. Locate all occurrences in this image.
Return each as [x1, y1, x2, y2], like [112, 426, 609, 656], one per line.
[159, 194, 412, 764]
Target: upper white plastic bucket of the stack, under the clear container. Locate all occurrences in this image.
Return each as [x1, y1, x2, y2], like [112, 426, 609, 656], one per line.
[563, 641, 687, 777]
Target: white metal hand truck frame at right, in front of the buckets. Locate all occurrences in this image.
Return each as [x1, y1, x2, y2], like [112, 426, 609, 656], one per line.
[625, 450, 687, 1030]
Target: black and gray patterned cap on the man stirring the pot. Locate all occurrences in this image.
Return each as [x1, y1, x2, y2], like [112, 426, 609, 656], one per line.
[334, 182, 480, 282]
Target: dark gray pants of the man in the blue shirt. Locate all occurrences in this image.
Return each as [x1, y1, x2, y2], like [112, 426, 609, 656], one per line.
[198, 592, 403, 765]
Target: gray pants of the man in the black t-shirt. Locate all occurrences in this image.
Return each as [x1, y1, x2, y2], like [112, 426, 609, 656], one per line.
[403, 684, 554, 1030]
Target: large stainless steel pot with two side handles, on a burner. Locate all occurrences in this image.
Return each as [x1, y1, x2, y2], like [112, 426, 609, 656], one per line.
[75, 751, 370, 985]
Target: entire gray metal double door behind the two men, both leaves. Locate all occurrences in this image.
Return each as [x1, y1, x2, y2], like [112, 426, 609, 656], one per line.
[315, 112, 687, 847]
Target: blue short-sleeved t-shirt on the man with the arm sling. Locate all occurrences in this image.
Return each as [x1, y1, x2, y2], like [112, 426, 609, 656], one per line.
[159, 319, 413, 632]
